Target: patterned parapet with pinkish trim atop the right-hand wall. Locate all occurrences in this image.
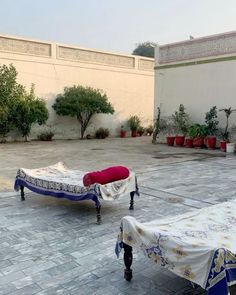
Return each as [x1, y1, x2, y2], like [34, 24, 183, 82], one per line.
[157, 31, 236, 64]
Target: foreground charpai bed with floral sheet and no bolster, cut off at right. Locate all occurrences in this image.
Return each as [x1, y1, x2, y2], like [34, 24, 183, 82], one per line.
[116, 201, 236, 295]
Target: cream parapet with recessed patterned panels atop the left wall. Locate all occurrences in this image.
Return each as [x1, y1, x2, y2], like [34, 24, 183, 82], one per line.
[0, 36, 154, 71]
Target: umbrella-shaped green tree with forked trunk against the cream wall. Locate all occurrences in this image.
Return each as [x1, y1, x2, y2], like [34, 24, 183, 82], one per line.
[52, 85, 114, 139]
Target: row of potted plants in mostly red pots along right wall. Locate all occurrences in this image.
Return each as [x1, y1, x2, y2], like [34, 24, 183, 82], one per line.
[158, 104, 236, 151]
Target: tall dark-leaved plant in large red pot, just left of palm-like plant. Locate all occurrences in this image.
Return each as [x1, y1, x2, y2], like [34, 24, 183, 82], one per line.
[205, 106, 219, 149]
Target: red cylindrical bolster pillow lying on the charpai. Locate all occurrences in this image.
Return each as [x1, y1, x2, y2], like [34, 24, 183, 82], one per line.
[83, 166, 129, 186]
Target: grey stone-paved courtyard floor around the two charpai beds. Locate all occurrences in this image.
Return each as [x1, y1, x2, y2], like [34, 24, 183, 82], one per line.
[0, 137, 236, 295]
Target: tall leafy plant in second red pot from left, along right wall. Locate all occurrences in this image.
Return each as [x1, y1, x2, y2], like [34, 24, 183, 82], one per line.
[172, 104, 189, 146]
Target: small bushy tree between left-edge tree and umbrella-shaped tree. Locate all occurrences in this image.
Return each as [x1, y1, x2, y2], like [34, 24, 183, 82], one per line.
[12, 85, 48, 141]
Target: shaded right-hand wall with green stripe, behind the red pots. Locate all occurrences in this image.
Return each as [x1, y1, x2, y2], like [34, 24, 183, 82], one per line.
[154, 32, 236, 136]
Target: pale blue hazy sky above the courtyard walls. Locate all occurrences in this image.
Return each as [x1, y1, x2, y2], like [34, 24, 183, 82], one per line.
[0, 0, 236, 54]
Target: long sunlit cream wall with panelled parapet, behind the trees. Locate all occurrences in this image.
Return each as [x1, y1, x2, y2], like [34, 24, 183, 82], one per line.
[0, 36, 154, 138]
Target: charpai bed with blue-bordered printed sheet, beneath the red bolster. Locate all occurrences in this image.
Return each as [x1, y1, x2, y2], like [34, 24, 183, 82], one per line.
[14, 162, 138, 223]
